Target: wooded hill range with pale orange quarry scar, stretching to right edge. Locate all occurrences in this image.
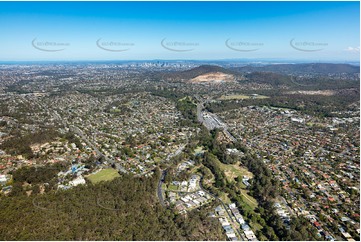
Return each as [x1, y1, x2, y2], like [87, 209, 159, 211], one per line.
[158, 63, 360, 88]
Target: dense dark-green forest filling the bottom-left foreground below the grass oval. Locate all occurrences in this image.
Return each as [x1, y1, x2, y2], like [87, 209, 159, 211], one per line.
[0, 172, 225, 240]
